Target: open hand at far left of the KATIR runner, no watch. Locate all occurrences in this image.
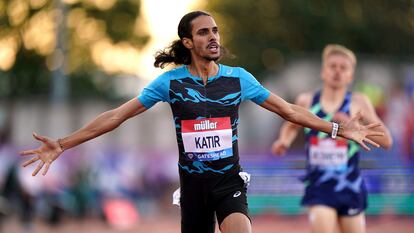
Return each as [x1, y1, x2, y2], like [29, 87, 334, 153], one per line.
[20, 133, 63, 176]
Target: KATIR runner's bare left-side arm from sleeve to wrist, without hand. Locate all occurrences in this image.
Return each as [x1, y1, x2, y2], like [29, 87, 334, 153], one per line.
[59, 98, 147, 150]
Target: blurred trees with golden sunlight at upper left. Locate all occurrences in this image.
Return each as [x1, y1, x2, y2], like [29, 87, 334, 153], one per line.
[0, 0, 149, 98]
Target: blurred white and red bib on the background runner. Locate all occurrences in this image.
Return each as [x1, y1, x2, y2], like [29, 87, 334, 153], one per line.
[309, 136, 348, 168]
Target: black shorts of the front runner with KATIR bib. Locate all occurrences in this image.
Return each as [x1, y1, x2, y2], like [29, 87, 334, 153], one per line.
[180, 170, 248, 233]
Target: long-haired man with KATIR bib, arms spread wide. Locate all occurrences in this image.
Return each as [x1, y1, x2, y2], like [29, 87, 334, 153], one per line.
[21, 11, 381, 233]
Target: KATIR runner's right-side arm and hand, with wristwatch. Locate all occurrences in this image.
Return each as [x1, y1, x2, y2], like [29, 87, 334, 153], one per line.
[261, 93, 384, 150]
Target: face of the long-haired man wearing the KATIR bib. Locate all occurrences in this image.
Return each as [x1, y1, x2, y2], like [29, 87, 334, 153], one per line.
[187, 15, 220, 61]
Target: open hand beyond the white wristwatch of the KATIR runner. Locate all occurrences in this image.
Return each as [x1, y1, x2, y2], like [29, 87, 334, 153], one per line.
[341, 112, 384, 150]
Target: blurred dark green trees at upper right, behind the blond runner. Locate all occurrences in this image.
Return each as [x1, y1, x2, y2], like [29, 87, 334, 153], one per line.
[207, 0, 414, 78]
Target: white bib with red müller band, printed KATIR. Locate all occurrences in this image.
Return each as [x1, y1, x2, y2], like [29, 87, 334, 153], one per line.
[181, 117, 233, 161]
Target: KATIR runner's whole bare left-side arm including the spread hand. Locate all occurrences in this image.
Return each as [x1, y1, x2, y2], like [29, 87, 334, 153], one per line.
[20, 98, 146, 176]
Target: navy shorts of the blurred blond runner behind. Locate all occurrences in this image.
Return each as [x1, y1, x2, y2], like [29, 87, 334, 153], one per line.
[302, 185, 367, 216]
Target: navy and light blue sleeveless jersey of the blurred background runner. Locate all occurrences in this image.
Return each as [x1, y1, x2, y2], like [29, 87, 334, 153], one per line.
[304, 91, 363, 193]
